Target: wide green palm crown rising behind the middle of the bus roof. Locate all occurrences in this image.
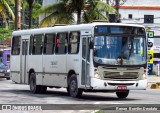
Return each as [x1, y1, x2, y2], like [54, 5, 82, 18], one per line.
[34, 0, 115, 25]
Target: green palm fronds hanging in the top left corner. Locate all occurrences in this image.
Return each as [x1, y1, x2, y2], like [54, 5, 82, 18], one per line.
[0, 0, 15, 28]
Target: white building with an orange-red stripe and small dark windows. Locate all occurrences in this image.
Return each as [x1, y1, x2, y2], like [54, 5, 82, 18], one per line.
[119, 0, 160, 37]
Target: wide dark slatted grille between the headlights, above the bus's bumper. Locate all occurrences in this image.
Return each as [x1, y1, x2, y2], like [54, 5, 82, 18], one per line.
[104, 72, 139, 79]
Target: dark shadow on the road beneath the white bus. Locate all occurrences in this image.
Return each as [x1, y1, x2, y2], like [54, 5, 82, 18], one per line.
[0, 89, 138, 101]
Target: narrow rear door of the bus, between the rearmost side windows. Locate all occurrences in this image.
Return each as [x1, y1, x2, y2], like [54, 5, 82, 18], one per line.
[20, 39, 28, 83]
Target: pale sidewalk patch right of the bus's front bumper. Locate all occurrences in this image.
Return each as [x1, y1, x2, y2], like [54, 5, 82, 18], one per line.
[147, 75, 160, 89]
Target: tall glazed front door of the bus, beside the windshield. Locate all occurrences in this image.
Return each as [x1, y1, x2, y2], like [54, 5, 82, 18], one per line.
[81, 36, 91, 88]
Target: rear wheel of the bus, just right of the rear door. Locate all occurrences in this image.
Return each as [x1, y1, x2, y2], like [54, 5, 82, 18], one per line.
[29, 73, 41, 93]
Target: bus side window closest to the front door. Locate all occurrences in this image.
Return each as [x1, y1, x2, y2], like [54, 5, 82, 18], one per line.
[68, 32, 80, 54]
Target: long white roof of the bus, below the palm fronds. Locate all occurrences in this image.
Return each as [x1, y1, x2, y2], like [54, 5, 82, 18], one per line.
[12, 22, 144, 36]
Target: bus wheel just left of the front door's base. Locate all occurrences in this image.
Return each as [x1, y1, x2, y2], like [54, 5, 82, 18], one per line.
[69, 75, 83, 97]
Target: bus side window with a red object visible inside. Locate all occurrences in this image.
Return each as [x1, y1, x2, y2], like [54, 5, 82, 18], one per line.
[55, 33, 68, 54]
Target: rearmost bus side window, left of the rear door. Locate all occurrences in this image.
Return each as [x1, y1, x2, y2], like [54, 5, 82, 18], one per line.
[11, 36, 21, 55]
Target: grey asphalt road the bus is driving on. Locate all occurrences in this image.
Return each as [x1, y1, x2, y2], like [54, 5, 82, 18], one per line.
[0, 79, 160, 113]
